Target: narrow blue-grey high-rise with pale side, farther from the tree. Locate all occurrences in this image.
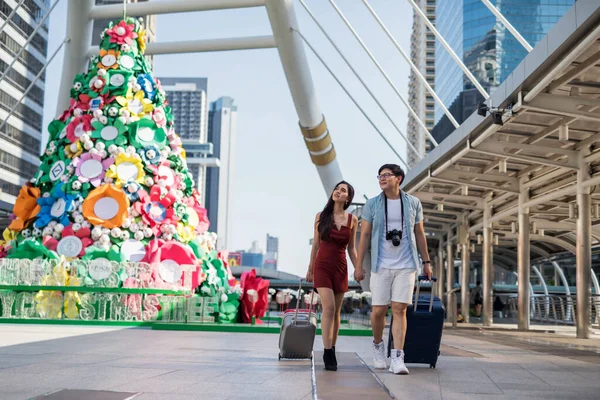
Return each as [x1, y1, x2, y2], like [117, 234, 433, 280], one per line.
[205, 97, 237, 249]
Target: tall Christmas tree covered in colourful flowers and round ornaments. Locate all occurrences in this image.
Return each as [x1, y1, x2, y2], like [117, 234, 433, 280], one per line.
[0, 18, 239, 320]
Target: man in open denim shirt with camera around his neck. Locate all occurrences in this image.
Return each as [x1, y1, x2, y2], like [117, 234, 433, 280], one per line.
[354, 164, 432, 375]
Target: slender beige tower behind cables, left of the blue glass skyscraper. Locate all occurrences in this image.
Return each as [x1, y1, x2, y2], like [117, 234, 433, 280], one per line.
[407, 0, 436, 167]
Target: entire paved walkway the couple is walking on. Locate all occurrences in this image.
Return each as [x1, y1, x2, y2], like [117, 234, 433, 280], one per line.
[0, 325, 600, 400]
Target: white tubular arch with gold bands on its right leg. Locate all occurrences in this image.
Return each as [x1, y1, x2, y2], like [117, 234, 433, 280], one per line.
[57, 0, 342, 193]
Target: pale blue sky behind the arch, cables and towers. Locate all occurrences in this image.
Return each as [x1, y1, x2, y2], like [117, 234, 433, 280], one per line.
[43, 0, 412, 276]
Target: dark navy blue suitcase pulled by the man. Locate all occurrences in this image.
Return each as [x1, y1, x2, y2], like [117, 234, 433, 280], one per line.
[388, 276, 446, 368]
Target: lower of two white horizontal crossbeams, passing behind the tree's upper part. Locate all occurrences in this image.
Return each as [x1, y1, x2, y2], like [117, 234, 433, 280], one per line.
[87, 36, 277, 57]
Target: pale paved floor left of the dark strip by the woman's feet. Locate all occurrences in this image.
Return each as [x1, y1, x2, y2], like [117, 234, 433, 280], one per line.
[0, 326, 312, 400]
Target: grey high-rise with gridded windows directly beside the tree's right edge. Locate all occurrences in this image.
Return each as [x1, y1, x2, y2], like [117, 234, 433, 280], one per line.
[160, 78, 219, 204]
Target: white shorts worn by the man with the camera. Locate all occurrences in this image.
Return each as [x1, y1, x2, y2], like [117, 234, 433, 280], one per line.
[371, 268, 417, 306]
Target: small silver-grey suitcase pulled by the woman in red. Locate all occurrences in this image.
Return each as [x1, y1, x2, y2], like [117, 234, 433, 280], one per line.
[279, 282, 317, 360]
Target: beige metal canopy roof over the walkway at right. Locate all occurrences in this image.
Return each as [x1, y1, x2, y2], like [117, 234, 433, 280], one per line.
[403, 0, 600, 269]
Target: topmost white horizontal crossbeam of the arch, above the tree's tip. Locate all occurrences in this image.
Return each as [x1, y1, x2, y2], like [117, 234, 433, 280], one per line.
[88, 0, 265, 20]
